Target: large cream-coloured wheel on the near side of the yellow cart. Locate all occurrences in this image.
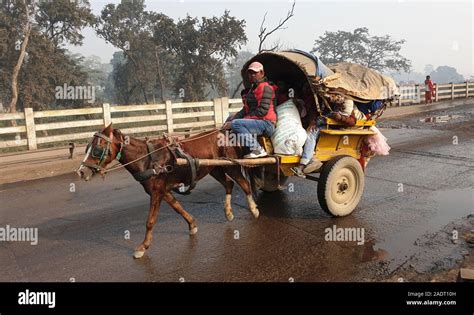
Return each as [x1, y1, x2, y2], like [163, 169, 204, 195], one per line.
[318, 156, 365, 217]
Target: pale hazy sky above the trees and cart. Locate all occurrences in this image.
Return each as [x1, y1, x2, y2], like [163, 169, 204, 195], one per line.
[69, 0, 474, 78]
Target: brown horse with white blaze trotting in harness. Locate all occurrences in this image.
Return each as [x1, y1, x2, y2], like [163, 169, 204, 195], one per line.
[77, 124, 259, 258]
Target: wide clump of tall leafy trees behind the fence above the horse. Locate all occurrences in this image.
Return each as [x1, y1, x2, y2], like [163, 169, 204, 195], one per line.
[96, 0, 247, 104]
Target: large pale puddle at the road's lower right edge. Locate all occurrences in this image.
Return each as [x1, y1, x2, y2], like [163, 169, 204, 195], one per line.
[374, 187, 474, 270]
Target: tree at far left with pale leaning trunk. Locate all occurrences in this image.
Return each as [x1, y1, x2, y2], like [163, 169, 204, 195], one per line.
[0, 0, 94, 112]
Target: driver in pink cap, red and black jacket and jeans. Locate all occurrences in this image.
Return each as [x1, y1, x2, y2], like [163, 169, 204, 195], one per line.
[224, 61, 277, 158]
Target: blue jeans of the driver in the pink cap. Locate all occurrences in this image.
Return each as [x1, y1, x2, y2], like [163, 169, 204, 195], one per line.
[231, 119, 275, 150]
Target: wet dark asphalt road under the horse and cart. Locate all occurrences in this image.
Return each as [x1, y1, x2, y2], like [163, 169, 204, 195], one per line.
[0, 105, 474, 282]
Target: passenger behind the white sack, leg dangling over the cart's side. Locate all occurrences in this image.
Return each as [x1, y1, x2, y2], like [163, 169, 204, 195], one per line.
[291, 84, 325, 177]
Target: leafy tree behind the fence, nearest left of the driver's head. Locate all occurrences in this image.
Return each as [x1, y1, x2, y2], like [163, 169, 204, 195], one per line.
[162, 11, 247, 101]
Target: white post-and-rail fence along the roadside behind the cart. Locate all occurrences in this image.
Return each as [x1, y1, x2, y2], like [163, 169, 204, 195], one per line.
[0, 82, 474, 150]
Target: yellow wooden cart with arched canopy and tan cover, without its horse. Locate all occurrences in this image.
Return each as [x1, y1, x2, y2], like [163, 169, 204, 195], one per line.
[177, 51, 397, 216]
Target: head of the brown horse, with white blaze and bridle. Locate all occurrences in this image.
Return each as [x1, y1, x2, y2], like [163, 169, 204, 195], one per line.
[77, 124, 124, 181]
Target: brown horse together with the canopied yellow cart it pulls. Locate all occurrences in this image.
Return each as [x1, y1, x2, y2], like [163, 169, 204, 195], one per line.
[77, 51, 396, 258]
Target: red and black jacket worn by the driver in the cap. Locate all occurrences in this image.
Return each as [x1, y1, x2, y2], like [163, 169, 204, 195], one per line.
[234, 81, 277, 123]
